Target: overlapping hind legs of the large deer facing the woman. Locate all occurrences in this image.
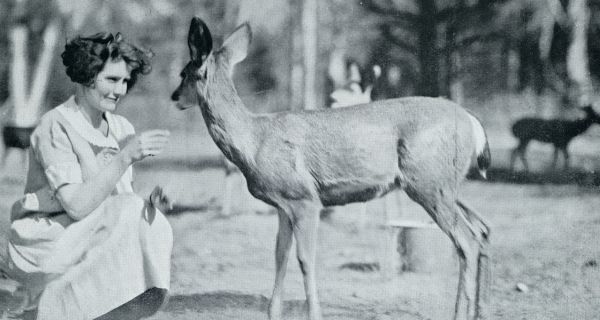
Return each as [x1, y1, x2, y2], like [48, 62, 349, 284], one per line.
[406, 184, 489, 320]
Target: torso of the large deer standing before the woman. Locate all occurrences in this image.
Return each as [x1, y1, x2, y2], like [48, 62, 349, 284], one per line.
[250, 98, 472, 205]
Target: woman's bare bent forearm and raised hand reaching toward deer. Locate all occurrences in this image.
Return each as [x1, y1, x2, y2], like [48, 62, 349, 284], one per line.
[56, 130, 169, 220]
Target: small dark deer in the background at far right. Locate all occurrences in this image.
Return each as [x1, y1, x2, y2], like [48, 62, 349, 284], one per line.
[510, 106, 600, 171]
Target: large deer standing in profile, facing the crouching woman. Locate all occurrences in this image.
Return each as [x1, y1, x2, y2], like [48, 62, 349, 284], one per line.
[171, 17, 491, 320]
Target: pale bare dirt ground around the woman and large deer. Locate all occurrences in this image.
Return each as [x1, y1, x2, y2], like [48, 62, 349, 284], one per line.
[0, 131, 600, 320]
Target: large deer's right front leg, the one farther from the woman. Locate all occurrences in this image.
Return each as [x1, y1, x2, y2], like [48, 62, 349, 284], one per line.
[293, 202, 322, 320]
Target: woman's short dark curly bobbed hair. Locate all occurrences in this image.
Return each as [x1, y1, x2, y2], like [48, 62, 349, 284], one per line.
[61, 32, 154, 90]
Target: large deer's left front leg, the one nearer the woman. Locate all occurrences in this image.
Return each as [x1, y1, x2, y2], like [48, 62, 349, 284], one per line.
[269, 209, 292, 320]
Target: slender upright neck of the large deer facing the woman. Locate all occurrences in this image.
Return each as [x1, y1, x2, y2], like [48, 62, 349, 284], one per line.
[201, 74, 256, 168]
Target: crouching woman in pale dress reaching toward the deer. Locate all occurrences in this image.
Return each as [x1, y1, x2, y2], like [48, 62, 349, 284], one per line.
[9, 33, 172, 320]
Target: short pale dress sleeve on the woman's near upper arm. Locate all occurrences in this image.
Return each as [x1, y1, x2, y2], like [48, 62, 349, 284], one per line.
[31, 121, 83, 191]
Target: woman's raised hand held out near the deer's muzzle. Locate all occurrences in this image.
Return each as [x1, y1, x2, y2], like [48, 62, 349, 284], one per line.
[122, 130, 170, 163]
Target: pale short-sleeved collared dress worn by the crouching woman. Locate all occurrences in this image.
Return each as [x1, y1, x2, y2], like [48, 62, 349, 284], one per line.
[8, 97, 173, 320]
